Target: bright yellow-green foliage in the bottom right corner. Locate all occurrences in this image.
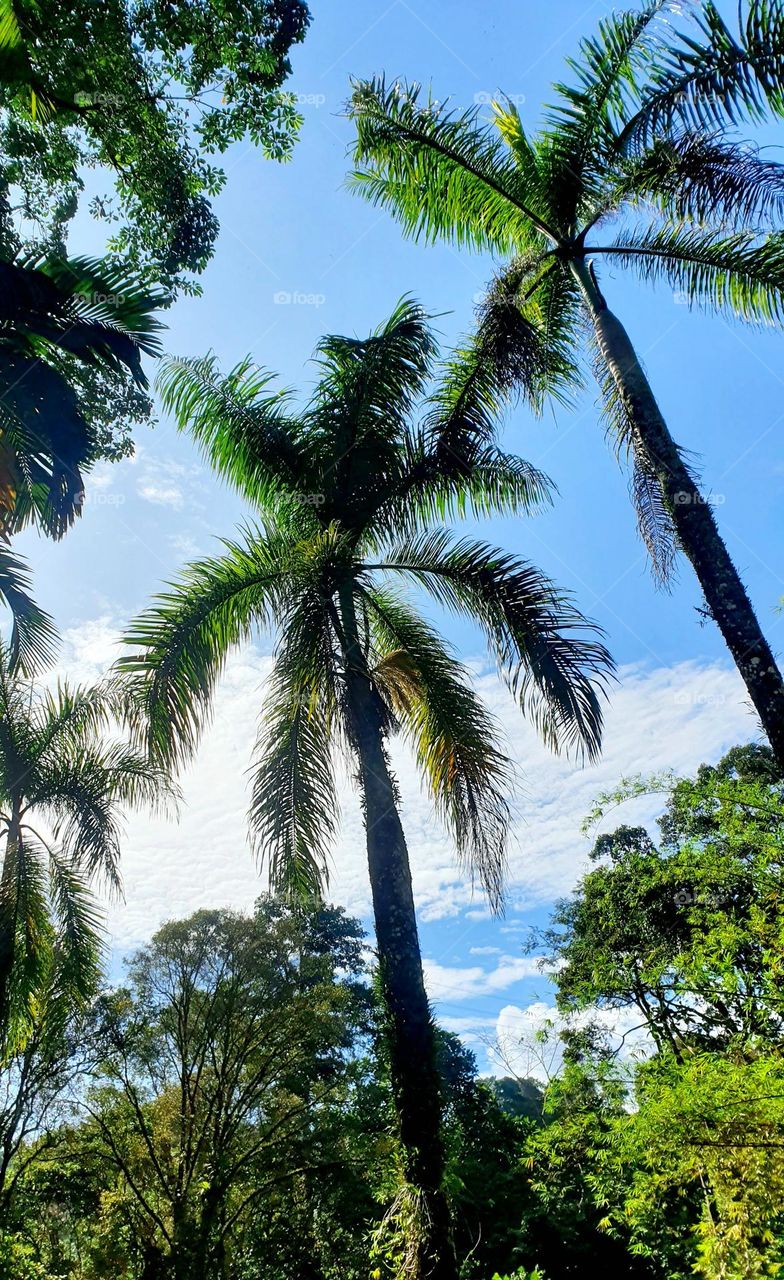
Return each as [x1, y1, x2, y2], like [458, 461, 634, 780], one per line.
[622, 1043, 784, 1280]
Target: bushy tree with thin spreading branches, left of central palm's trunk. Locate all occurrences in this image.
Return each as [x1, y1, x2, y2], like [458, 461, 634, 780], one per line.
[72, 901, 369, 1280]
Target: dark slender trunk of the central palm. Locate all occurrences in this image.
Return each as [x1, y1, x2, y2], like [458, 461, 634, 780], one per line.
[341, 590, 457, 1280]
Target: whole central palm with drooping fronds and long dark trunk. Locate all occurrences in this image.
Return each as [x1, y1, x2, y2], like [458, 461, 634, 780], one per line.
[120, 300, 611, 1277]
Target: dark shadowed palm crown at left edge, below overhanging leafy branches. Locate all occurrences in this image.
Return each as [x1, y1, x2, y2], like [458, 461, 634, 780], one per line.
[0, 256, 163, 539]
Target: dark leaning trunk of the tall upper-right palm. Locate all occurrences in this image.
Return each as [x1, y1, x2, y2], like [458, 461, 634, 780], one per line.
[571, 260, 784, 768]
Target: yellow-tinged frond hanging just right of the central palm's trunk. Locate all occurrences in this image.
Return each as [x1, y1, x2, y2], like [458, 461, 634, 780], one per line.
[364, 588, 511, 910]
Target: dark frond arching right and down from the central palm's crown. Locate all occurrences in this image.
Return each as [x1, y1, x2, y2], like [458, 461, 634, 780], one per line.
[373, 531, 612, 759]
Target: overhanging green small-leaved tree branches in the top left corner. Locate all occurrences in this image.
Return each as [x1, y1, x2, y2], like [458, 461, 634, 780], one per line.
[0, 0, 310, 291]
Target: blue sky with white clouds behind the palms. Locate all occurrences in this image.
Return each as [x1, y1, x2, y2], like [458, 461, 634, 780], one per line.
[20, 0, 784, 1066]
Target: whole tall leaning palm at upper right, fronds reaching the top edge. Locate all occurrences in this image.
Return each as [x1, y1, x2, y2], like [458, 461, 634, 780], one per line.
[350, 0, 784, 764]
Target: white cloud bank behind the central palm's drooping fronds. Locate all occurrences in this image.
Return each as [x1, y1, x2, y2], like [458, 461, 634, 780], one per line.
[50, 618, 755, 952]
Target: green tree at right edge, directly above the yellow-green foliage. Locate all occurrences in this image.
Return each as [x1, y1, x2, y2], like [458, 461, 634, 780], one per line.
[543, 748, 784, 1057]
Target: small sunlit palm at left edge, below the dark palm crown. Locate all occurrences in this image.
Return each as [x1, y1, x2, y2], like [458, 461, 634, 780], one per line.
[0, 648, 170, 1059]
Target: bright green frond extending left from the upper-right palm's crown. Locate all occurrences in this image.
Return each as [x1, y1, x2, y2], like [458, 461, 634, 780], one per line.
[348, 78, 559, 253]
